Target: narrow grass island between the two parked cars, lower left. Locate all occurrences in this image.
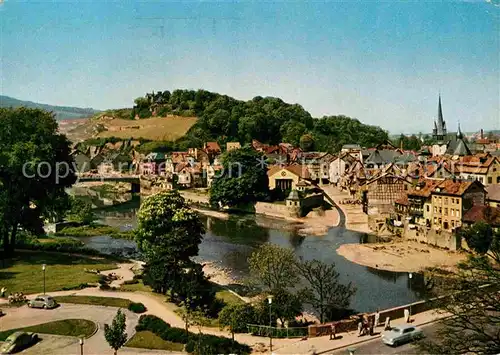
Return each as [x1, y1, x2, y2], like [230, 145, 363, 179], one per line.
[0, 319, 97, 341]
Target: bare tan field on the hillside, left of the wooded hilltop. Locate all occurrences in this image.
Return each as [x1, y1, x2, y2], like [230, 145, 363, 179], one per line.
[66, 116, 197, 142]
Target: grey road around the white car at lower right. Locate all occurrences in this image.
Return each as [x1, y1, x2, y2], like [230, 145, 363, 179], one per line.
[329, 323, 439, 355]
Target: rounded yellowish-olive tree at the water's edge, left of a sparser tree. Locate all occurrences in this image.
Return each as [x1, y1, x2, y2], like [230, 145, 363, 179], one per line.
[248, 243, 299, 292]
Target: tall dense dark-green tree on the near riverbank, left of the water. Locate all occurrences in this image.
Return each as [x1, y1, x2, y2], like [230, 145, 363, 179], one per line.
[135, 191, 215, 310]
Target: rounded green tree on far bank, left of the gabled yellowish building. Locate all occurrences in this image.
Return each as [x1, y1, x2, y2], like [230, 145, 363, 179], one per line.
[210, 147, 269, 206]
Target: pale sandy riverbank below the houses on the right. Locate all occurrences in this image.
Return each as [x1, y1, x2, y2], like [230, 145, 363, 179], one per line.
[337, 241, 466, 272]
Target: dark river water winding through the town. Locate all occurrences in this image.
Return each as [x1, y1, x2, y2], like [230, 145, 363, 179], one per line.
[74, 197, 425, 312]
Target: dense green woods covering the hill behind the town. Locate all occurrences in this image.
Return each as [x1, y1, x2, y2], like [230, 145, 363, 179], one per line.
[131, 90, 388, 152]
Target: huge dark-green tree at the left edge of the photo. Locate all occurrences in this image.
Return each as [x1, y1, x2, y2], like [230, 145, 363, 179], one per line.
[0, 108, 76, 255]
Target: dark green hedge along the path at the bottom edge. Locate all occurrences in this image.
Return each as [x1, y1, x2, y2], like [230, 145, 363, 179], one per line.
[135, 315, 251, 355]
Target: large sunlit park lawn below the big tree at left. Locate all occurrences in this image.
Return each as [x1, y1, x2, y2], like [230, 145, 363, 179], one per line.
[0, 251, 117, 294]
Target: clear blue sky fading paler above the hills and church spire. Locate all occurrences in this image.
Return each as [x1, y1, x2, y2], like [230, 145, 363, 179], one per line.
[0, 0, 500, 134]
